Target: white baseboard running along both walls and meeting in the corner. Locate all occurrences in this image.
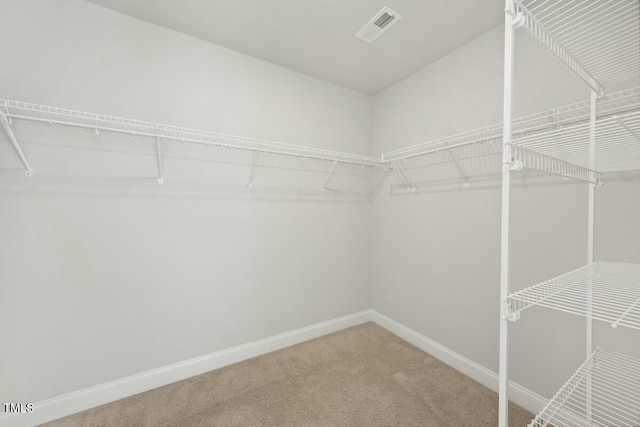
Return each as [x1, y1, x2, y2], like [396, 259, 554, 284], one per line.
[0, 310, 546, 427]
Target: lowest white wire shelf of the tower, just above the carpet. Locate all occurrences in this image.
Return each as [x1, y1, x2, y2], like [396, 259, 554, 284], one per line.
[529, 348, 640, 427]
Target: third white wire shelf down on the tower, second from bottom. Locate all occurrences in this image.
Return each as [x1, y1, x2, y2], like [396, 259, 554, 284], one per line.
[507, 261, 640, 330]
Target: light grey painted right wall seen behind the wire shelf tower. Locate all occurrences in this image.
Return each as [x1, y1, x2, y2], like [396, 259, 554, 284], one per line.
[372, 27, 640, 397]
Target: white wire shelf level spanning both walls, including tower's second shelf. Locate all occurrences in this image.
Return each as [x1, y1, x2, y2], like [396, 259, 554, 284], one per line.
[0, 88, 640, 197]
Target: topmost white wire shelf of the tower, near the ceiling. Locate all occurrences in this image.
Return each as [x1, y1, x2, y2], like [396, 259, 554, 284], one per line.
[513, 0, 640, 93]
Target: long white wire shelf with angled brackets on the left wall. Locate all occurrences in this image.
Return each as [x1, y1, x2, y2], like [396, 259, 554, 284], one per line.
[0, 99, 392, 199]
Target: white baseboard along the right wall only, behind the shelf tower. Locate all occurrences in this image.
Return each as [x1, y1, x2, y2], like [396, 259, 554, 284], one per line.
[371, 310, 547, 414]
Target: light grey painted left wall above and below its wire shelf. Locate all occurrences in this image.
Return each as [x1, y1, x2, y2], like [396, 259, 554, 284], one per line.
[0, 0, 371, 402]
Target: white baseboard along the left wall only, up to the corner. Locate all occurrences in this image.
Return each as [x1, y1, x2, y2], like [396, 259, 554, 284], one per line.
[0, 310, 371, 427]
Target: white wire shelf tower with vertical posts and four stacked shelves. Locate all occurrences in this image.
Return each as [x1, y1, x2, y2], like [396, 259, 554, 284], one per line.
[499, 0, 640, 427]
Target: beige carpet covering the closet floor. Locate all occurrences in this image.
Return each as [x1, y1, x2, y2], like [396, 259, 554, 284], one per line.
[46, 323, 533, 427]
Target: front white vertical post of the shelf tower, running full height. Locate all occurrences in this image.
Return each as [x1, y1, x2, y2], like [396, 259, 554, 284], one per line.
[498, 0, 515, 427]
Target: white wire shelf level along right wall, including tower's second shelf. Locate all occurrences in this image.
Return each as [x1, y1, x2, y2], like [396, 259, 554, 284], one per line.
[382, 87, 640, 185]
